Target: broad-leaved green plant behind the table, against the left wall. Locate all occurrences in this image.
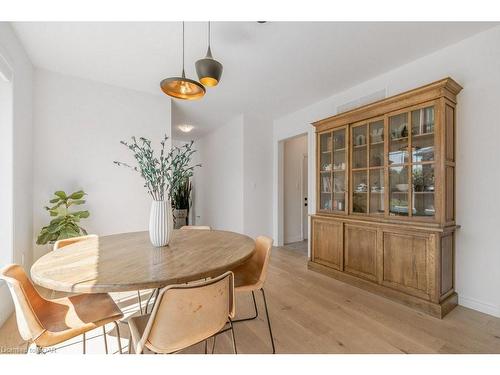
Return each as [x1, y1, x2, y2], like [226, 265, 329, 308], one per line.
[36, 190, 90, 245]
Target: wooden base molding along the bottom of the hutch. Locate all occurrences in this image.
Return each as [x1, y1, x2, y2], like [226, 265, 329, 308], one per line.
[308, 261, 458, 319]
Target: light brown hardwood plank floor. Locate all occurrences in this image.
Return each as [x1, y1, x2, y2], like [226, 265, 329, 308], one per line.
[0, 244, 500, 354]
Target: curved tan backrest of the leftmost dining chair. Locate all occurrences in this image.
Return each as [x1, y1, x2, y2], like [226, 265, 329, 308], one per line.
[0, 264, 47, 341]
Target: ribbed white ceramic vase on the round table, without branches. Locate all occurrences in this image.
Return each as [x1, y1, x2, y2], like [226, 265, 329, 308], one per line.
[149, 201, 174, 247]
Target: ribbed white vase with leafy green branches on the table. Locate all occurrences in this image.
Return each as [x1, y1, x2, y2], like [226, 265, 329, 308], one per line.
[114, 135, 201, 247]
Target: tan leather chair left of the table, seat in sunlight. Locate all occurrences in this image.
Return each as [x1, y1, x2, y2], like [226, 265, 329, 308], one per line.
[0, 264, 123, 353]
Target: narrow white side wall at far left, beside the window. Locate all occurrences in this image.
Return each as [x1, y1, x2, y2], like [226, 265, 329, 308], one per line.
[0, 22, 33, 326]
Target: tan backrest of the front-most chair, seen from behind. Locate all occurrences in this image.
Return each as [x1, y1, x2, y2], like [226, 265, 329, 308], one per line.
[136, 272, 235, 353]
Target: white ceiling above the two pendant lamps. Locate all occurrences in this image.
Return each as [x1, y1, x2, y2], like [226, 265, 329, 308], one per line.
[13, 22, 496, 138]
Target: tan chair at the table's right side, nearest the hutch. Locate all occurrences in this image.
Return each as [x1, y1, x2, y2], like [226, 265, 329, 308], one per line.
[233, 236, 276, 354]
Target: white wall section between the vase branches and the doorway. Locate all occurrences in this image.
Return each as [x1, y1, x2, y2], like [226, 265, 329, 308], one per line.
[193, 115, 272, 238]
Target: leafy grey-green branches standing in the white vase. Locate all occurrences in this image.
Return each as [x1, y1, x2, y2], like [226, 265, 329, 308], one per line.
[113, 135, 201, 201]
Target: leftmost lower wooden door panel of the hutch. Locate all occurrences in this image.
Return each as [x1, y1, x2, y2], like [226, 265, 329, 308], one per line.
[311, 219, 343, 270]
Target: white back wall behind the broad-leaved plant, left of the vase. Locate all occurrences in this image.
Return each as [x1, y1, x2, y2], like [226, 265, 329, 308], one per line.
[33, 69, 171, 257]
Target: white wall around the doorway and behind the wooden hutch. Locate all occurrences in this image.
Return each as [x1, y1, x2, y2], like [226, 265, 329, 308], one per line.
[273, 27, 500, 316]
